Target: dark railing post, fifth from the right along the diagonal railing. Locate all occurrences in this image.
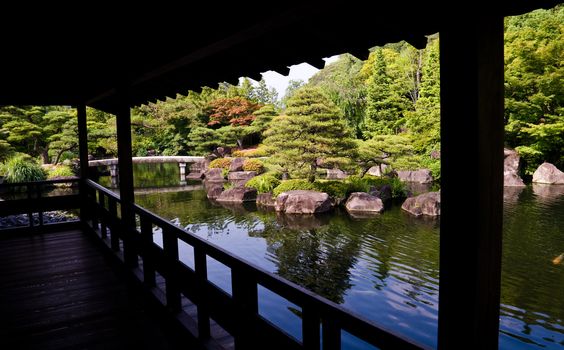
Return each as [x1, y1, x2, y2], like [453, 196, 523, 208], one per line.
[162, 227, 181, 311]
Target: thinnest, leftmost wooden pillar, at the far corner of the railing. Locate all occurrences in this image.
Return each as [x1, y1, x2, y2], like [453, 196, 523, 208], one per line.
[76, 104, 89, 224]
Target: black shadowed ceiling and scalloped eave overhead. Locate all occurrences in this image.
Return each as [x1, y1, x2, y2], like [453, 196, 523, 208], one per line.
[0, 0, 560, 112]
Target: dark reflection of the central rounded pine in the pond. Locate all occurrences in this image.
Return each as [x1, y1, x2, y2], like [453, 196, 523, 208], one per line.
[249, 214, 360, 303]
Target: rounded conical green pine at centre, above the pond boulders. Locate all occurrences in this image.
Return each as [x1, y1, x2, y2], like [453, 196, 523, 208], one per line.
[264, 87, 356, 182]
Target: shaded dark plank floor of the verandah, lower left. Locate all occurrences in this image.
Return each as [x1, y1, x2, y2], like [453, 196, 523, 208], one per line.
[0, 230, 199, 350]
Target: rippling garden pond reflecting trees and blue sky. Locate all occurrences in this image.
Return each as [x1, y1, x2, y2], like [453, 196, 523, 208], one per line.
[101, 165, 564, 349]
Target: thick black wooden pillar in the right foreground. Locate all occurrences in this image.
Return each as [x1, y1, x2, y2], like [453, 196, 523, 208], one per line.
[438, 13, 503, 349]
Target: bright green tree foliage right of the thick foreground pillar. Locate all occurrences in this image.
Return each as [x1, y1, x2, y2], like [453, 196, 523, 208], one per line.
[505, 5, 564, 174]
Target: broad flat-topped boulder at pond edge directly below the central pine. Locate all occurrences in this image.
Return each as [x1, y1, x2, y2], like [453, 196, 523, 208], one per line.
[275, 190, 333, 214]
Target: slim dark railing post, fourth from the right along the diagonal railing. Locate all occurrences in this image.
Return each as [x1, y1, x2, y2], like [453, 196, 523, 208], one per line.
[194, 247, 210, 340]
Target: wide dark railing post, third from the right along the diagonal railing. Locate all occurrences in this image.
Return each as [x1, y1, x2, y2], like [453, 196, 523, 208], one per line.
[231, 266, 259, 350]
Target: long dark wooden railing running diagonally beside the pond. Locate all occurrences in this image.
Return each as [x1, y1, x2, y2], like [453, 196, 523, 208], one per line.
[87, 181, 424, 350]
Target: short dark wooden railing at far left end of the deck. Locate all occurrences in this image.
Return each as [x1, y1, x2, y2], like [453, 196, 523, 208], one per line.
[0, 178, 80, 229]
